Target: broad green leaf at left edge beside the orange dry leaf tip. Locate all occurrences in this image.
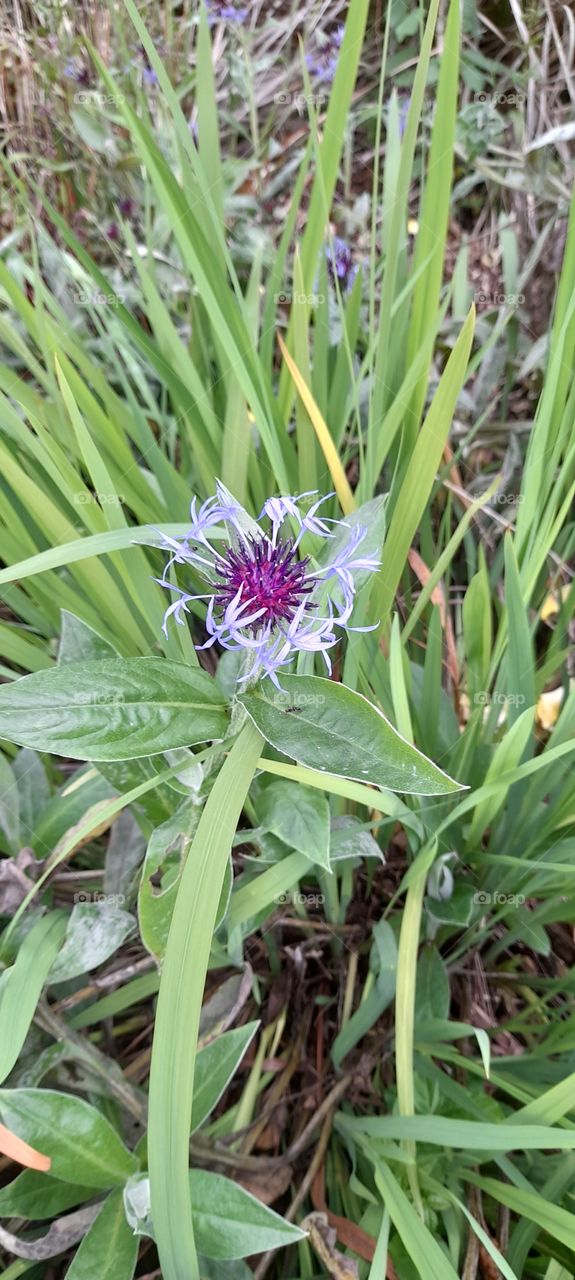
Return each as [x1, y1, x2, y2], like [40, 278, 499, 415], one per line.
[0, 1089, 138, 1190]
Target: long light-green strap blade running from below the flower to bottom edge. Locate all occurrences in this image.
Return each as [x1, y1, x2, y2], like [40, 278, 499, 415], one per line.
[147, 721, 264, 1280]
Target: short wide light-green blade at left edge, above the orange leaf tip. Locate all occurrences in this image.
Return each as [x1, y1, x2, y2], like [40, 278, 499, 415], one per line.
[0, 911, 65, 1083]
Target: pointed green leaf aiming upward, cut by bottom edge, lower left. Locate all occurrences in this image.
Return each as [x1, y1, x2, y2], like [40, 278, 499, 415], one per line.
[65, 1190, 138, 1280]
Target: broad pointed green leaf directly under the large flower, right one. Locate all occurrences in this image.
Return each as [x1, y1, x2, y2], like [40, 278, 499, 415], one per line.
[238, 676, 461, 795]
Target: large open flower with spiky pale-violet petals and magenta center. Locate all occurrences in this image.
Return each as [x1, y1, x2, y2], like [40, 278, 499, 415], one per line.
[159, 483, 379, 689]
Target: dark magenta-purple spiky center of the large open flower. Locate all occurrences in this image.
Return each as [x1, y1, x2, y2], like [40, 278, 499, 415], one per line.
[215, 538, 312, 631]
